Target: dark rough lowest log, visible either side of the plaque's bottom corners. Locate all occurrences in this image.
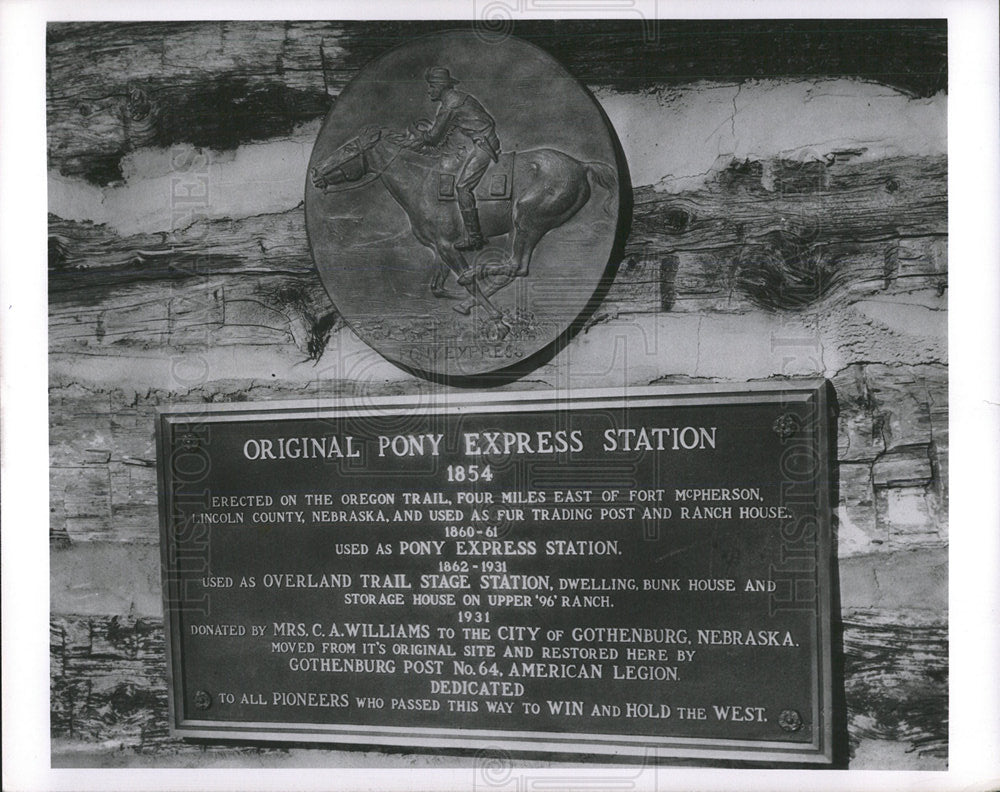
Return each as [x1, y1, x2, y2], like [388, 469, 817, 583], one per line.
[49, 611, 948, 758]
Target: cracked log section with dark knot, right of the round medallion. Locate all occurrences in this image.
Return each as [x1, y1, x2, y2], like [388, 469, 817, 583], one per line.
[621, 158, 947, 310]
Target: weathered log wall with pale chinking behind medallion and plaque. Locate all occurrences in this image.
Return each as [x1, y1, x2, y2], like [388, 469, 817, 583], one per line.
[47, 23, 948, 768]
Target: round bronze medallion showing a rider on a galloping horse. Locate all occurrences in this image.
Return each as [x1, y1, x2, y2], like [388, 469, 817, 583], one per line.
[305, 32, 629, 377]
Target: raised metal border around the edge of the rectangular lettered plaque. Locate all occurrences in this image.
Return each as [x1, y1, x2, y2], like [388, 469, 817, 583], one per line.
[155, 378, 835, 765]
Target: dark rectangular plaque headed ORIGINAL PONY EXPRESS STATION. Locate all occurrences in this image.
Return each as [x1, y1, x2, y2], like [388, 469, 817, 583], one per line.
[157, 381, 831, 763]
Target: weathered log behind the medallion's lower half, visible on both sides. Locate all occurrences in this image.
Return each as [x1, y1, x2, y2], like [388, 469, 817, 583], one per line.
[49, 152, 947, 366]
